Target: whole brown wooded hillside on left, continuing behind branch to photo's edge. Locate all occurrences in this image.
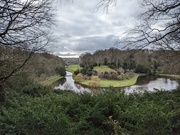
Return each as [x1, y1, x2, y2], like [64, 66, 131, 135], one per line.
[0, 45, 65, 82]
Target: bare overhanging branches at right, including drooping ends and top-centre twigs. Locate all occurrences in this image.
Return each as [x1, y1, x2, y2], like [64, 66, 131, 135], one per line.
[100, 0, 180, 73]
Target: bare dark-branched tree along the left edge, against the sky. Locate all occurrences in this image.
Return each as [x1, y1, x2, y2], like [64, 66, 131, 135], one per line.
[0, 0, 53, 101]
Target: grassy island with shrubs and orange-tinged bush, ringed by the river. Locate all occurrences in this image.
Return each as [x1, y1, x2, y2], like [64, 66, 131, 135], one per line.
[67, 65, 139, 87]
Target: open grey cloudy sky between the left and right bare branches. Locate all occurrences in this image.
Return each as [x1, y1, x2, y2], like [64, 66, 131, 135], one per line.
[48, 0, 142, 57]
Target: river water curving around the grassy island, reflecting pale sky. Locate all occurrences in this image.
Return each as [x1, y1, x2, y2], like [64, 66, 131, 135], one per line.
[55, 71, 180, 93]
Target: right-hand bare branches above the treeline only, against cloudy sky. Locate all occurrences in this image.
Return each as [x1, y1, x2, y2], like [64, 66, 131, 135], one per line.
[126, 0, 180, 51]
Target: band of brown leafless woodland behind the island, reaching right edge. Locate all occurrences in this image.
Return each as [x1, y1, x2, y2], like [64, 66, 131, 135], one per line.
[80, 48, 180, 74]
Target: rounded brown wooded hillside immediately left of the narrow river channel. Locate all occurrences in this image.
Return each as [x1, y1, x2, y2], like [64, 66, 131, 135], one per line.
[22, 53, 65, 82]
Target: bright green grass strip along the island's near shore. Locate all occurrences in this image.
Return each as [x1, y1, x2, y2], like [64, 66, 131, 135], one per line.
[80, 74, 139, 87]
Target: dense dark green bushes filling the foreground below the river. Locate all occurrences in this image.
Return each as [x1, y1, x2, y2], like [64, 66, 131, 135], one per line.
[0, 84, 180, 135]
